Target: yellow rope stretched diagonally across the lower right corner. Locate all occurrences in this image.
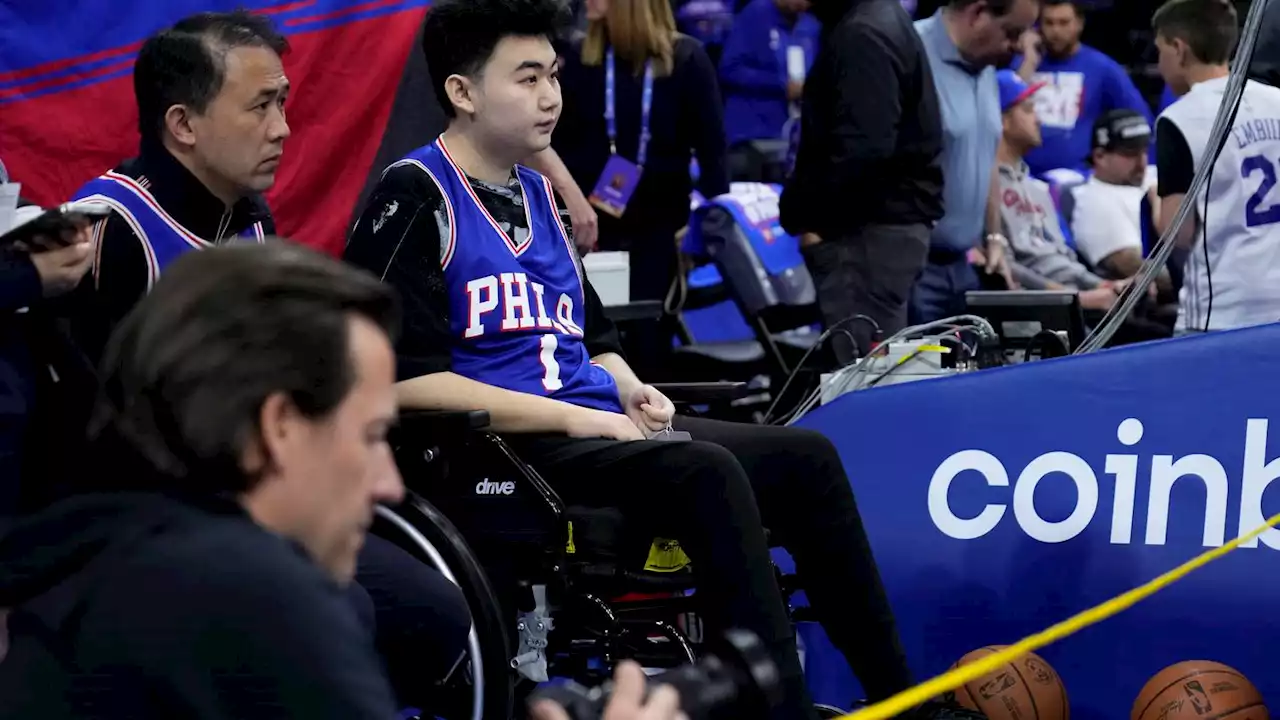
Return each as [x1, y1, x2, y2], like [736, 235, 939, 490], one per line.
[838, 514, 1280, 720]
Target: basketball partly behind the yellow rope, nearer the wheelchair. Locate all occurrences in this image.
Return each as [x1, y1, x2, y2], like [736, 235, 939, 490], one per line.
[952, 644, 1071, 720]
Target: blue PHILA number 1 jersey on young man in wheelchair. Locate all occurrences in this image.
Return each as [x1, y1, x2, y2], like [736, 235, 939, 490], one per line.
[393, 138, 622, 413]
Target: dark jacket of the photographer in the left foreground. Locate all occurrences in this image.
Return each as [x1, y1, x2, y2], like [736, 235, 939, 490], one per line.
[0, 484, 396, 720]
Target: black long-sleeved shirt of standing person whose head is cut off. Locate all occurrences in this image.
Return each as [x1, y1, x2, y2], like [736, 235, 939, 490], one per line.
[780, 0, 943, 238]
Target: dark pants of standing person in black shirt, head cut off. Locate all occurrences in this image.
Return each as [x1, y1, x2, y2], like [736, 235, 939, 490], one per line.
[804, 224, 929, 365]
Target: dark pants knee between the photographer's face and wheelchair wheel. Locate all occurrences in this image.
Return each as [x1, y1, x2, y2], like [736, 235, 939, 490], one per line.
[349, 536, 471, 710]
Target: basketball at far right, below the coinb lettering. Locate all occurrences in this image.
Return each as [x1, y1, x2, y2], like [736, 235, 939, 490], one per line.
[1130, 660, 1268, 720]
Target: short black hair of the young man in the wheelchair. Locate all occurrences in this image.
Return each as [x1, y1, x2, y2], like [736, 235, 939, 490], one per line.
[422, 0, 568, 118]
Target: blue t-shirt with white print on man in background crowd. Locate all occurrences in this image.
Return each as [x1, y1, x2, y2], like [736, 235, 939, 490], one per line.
[1012, 45, 1152, 176]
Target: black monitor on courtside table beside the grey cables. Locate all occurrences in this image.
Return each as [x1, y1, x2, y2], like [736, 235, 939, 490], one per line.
[965, 290, 1085, 360]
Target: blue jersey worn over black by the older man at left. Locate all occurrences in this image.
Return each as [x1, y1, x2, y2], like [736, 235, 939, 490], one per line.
[73, 170, 264, 290]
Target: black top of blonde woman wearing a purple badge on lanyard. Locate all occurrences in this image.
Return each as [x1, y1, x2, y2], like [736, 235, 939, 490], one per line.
[552, 36, 728, 243]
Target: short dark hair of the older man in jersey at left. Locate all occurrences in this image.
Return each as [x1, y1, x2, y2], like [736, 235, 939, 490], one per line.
[133, 10, 289, 140]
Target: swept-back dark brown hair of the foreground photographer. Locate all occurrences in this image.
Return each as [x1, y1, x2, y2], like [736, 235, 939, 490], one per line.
[88, 240, 399, 495]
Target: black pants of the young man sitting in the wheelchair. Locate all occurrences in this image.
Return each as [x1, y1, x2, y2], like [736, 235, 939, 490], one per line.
[507, 418, 911, 719]
